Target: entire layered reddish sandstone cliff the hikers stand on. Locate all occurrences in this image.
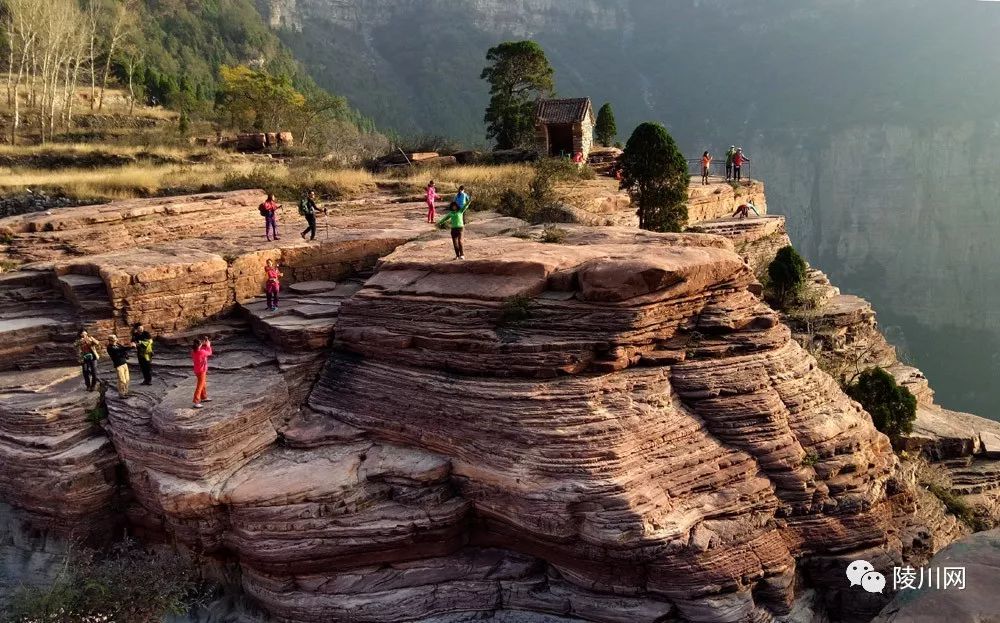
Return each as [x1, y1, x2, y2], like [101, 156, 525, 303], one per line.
[0, 187, 996, 622]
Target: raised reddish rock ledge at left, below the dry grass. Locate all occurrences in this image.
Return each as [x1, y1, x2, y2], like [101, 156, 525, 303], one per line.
[0, 191, 428, 334]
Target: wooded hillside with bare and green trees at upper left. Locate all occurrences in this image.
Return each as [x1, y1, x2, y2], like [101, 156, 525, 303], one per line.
[0, 0, 374, 144]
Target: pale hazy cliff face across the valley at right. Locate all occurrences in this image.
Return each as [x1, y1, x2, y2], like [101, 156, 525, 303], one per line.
[757, 122, 1000, 418]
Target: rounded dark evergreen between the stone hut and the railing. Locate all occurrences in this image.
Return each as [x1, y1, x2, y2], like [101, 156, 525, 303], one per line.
[621, 122, 691, 232]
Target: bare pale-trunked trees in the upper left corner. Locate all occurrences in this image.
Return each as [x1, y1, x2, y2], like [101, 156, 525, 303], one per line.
[0, 0, 141, 141]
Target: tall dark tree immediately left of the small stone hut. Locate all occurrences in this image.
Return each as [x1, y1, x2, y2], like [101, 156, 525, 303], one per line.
[480, 41, 555, 149]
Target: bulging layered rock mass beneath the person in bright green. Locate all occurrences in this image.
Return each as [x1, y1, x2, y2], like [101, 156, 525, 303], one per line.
[288, 235, 898, 621]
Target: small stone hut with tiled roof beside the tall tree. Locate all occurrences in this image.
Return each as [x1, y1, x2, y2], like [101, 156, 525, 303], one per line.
[535, 97, 597, 161]
